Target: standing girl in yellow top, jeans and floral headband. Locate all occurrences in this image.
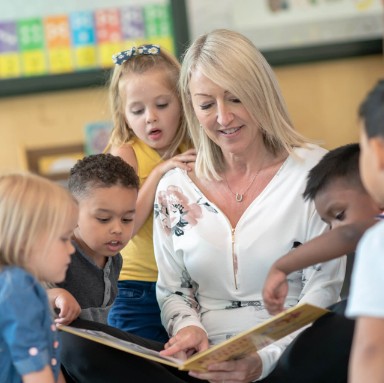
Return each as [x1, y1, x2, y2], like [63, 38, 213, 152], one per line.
[107, 45, 195, 342]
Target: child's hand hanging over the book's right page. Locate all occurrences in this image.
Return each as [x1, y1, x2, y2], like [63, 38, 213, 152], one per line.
[263, 265, 288, 315]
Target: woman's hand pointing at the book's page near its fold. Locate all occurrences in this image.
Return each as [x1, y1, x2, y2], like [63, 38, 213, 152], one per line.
[160, 326, 209, 359]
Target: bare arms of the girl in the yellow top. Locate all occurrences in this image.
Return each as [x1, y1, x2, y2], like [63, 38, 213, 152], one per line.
[110, 144, 196, 236]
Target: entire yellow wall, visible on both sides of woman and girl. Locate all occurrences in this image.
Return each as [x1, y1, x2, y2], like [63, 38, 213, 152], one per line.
[0, 55, 384, 171]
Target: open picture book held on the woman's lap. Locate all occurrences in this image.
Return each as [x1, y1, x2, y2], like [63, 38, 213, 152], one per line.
[58, 303, 329, 371]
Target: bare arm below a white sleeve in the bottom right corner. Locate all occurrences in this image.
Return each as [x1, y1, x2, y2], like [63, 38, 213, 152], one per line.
[349, 318, 384, 383]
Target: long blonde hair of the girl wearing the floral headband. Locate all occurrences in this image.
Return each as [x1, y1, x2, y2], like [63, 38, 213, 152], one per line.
[105, 48, 188, 157]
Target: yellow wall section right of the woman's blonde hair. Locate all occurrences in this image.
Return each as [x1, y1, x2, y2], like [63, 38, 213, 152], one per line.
[276, 55, 384, 149]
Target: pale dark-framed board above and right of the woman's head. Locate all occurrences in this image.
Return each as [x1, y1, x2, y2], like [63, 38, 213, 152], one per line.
[187, 0, 384, 65]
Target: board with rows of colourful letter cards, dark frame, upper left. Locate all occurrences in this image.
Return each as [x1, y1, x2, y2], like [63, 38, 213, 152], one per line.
[0, 0, 188, 96]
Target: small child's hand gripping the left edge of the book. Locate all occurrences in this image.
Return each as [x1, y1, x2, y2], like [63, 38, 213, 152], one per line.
[47, 287, 81, 325]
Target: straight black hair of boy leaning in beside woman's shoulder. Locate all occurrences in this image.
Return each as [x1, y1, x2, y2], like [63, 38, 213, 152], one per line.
[303, 143, 365, 200]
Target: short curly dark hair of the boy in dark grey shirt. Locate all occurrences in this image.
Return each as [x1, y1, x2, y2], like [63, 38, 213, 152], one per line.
[68, 153, 139, 198]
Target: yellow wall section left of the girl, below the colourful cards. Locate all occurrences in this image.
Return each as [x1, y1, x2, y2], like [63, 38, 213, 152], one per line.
[0, 87, 109, 171]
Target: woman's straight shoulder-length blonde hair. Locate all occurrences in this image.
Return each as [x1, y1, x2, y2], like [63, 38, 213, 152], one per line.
[179, 29, 309, 180]
